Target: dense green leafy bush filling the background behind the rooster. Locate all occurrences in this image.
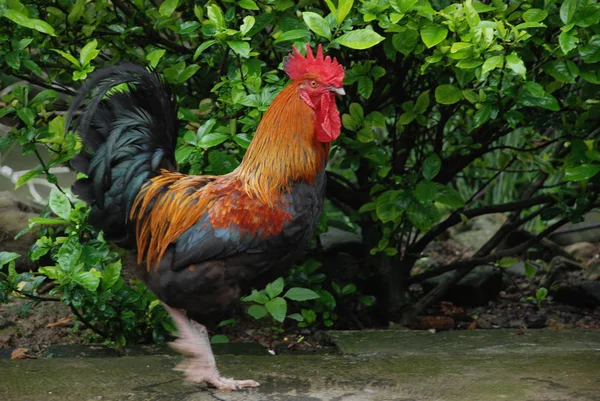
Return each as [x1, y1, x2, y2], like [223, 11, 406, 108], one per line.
[0, 0, 600, 340]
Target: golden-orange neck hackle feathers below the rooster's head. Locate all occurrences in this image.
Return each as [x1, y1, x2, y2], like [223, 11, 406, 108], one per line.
[232, 81, 329, 206]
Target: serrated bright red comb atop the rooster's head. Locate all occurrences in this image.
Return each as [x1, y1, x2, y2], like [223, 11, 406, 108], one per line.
[283, 43, 344, 87]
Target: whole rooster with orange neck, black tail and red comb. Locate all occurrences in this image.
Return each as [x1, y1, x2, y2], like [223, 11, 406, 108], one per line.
[67, 45, 344, 390]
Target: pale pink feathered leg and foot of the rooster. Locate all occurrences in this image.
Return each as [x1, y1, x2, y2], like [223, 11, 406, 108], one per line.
[165, 305, 259, 391]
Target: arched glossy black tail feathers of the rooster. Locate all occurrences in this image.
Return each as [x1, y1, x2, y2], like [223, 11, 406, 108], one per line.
[66, 64, 178, 246]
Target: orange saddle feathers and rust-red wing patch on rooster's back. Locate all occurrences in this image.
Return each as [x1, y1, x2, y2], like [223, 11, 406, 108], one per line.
[130, 171, 291, 270]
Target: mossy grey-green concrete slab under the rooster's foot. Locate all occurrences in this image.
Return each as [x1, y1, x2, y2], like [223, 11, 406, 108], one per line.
[0, 330, 600, 401]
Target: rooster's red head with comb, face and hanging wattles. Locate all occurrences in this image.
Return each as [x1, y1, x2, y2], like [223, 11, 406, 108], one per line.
[283, 44, 345, 142]
